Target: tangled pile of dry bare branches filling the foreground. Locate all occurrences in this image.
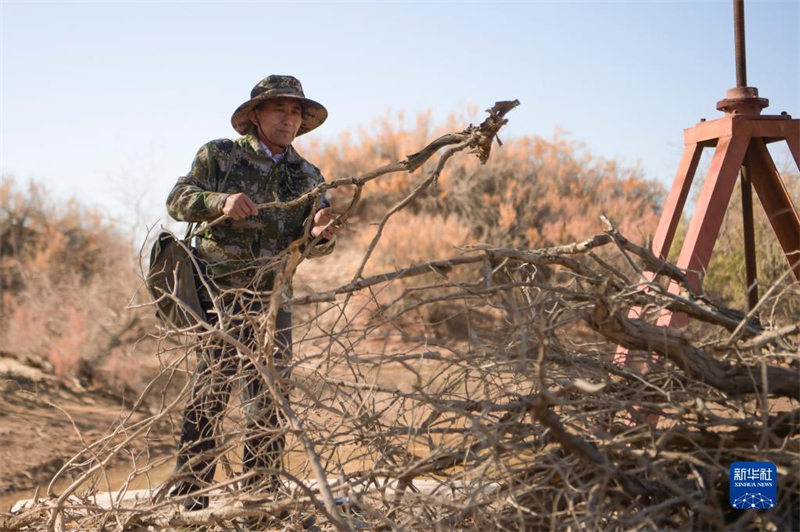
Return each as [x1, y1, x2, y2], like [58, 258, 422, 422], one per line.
[5, 102, 800, 530]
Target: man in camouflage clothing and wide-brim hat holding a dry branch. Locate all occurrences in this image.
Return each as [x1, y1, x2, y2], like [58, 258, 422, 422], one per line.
[167, 75, 338, 510]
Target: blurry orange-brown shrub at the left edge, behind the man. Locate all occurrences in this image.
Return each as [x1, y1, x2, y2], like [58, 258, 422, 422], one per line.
[0, 178, 148, 384]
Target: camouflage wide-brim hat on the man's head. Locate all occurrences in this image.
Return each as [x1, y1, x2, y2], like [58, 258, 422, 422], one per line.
[231, 75, 328, 136]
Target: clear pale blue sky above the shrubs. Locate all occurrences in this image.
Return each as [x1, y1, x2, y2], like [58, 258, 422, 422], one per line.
[0, 0, 800, 233]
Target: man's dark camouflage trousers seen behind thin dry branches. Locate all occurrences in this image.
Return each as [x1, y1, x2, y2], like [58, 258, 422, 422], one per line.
[172, 290, 292, 502]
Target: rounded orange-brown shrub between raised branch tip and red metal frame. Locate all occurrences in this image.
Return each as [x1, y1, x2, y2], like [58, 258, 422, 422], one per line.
[437, 132, 663, 248]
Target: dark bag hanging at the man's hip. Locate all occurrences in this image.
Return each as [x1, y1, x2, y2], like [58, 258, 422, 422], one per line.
[145, 226, 205, 329]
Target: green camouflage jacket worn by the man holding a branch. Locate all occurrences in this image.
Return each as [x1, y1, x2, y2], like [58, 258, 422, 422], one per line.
[167, 135, 335, 291]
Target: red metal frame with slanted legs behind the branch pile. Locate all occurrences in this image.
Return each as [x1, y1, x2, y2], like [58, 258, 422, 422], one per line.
[615, 92, 800, 362]
